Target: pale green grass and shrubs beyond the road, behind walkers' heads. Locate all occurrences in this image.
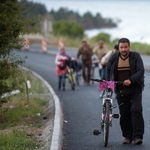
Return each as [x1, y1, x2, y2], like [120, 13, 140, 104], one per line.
[49, 33, 150, 55]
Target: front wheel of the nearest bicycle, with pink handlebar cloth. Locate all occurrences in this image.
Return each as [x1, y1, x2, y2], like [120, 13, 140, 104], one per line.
[104, 102, 110, 147]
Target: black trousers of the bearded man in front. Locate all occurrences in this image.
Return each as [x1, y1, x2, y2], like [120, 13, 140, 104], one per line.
[117, 84, 144, 139]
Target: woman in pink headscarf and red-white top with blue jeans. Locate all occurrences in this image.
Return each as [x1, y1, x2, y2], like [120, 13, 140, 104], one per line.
[55, 47, 71, 90]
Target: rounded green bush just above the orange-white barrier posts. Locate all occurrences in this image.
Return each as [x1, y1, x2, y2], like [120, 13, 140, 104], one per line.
[53, 21, 84, 37]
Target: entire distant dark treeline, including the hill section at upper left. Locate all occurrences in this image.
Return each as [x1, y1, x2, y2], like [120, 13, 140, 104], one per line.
[20, 0, 120, 29]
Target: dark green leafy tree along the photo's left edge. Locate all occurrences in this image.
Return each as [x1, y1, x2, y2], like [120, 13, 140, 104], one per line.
[0, 0, 36, 122]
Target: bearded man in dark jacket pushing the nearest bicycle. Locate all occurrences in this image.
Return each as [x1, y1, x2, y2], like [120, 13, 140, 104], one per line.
[106, 38, 144, 145]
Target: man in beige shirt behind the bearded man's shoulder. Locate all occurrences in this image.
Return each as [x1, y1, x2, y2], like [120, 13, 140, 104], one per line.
[93, 40, 108, 79]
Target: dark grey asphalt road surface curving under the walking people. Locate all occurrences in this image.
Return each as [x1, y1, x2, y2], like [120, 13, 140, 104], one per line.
[19, 48, 150, 150]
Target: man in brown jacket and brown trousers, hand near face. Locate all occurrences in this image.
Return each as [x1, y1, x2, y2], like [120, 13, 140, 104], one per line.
[77, 41, 93, 85]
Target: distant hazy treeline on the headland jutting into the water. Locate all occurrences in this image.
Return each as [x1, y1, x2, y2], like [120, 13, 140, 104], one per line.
[50, 8, 119, 29]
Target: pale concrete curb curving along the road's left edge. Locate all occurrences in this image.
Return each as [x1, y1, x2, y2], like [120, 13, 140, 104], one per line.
[22, 67, 63, 150]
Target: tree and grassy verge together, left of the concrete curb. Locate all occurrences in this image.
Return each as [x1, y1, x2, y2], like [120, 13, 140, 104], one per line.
[0, 0, 50, 150]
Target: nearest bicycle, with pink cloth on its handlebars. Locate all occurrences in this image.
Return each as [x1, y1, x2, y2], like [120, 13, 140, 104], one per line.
[91, 79, 123, 147]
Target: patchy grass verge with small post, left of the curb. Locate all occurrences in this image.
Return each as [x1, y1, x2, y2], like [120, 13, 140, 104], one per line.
[0, 72, 51, 150]
